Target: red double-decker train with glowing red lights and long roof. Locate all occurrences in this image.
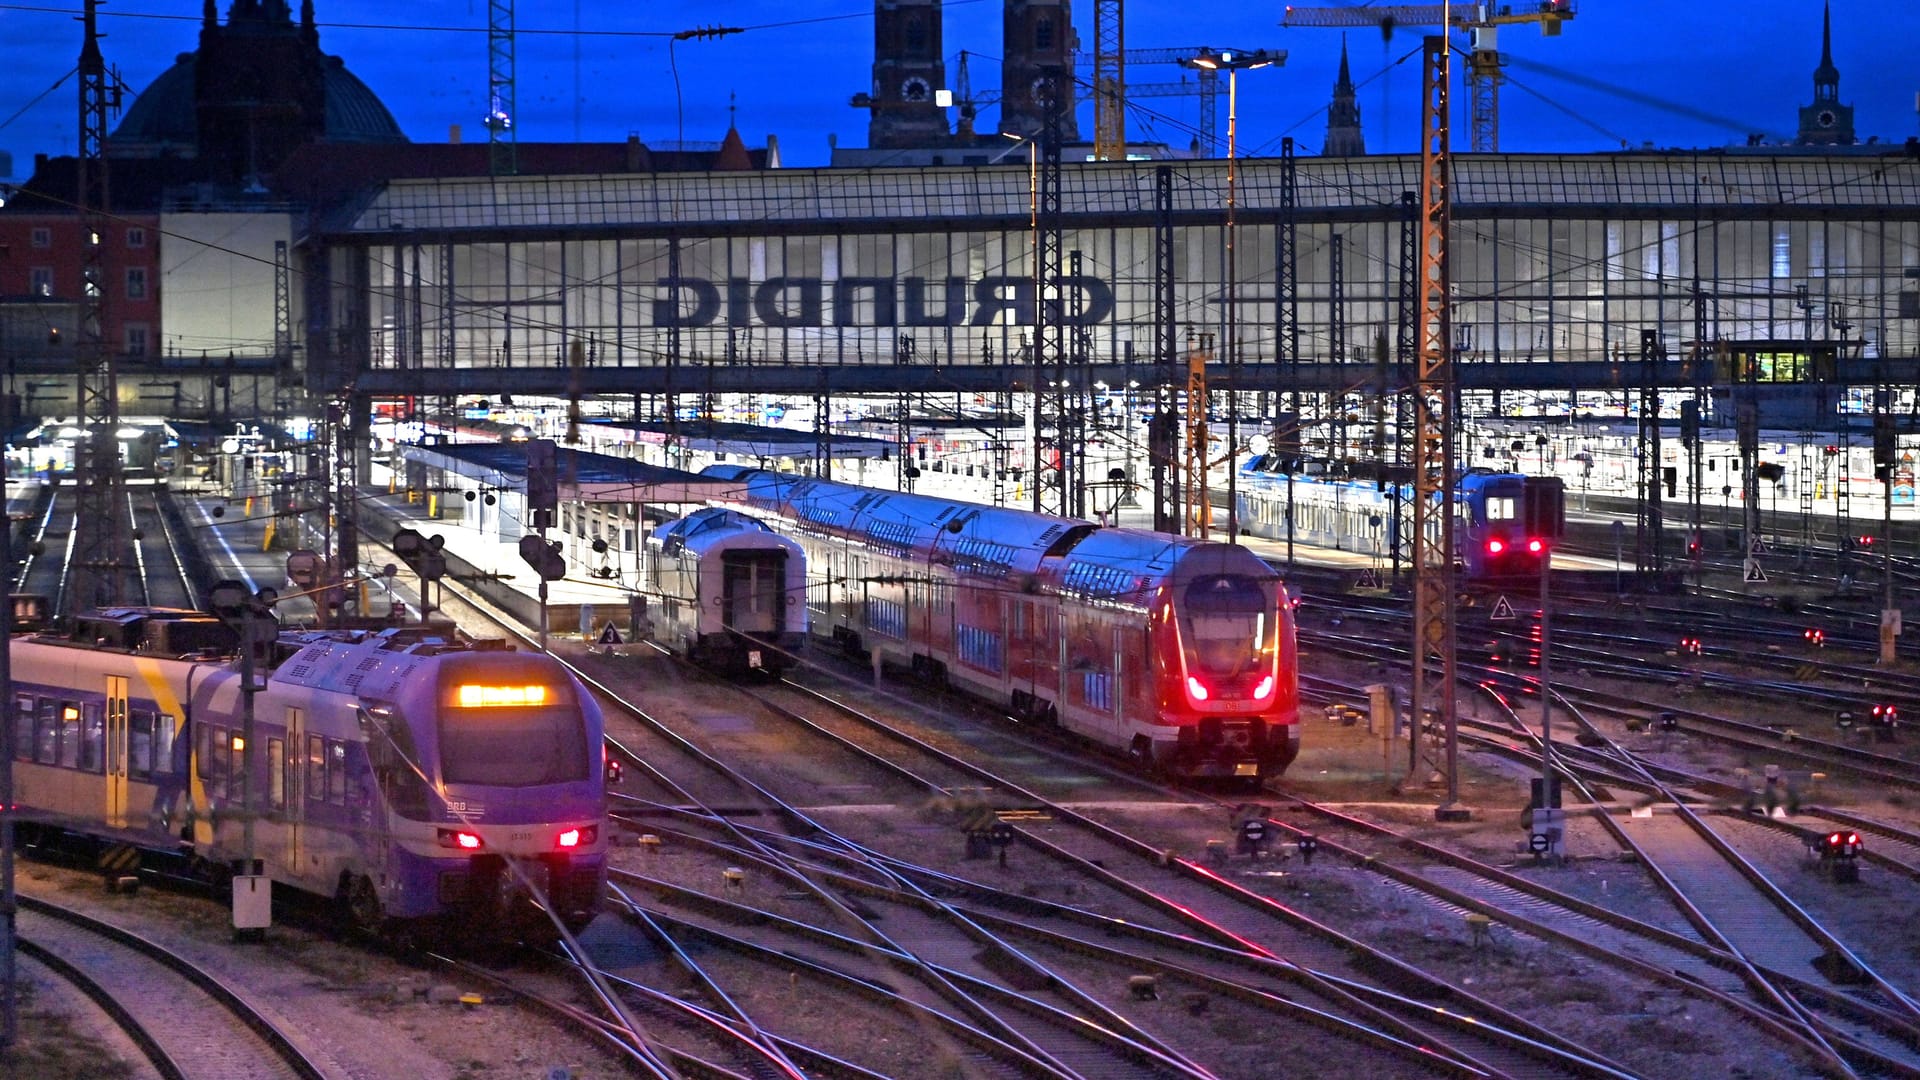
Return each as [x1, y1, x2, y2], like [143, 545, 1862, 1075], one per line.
[703, 465, 1300, 782]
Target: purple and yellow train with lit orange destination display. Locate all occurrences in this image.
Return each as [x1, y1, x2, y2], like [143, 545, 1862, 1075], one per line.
[10, 607, 609, 942]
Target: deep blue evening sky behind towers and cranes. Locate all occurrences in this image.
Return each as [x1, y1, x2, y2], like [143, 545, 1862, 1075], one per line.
[0, 0, 1920, 177]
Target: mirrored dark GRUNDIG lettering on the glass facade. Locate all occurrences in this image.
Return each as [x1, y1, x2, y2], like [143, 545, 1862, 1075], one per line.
[653, 275, 1114, 327]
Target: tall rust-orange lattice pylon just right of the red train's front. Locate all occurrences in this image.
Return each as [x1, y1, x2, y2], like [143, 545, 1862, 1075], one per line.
[1409, 37, 1459, 805]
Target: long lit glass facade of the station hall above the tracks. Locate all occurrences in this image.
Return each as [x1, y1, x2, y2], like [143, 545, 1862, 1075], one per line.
[324, 154, 1920, 378]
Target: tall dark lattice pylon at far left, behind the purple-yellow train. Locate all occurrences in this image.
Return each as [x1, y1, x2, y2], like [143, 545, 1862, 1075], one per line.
[61, 0, 136, 613]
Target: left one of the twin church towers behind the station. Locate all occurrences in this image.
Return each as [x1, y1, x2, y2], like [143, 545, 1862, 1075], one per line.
[866, 0, 947, 150]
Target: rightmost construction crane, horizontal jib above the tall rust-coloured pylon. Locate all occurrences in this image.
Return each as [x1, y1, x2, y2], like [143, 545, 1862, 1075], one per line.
[1281, 0, 1574, 154]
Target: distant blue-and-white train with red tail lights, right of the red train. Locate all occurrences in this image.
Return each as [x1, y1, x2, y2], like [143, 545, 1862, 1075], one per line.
[1236, 455, 1565, 580]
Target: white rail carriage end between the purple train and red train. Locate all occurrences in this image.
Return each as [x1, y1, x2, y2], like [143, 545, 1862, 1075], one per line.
[643, 507, 806, 675]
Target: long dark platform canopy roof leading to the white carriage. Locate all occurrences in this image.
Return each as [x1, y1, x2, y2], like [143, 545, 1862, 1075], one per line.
[399, 442, 739, 503]
